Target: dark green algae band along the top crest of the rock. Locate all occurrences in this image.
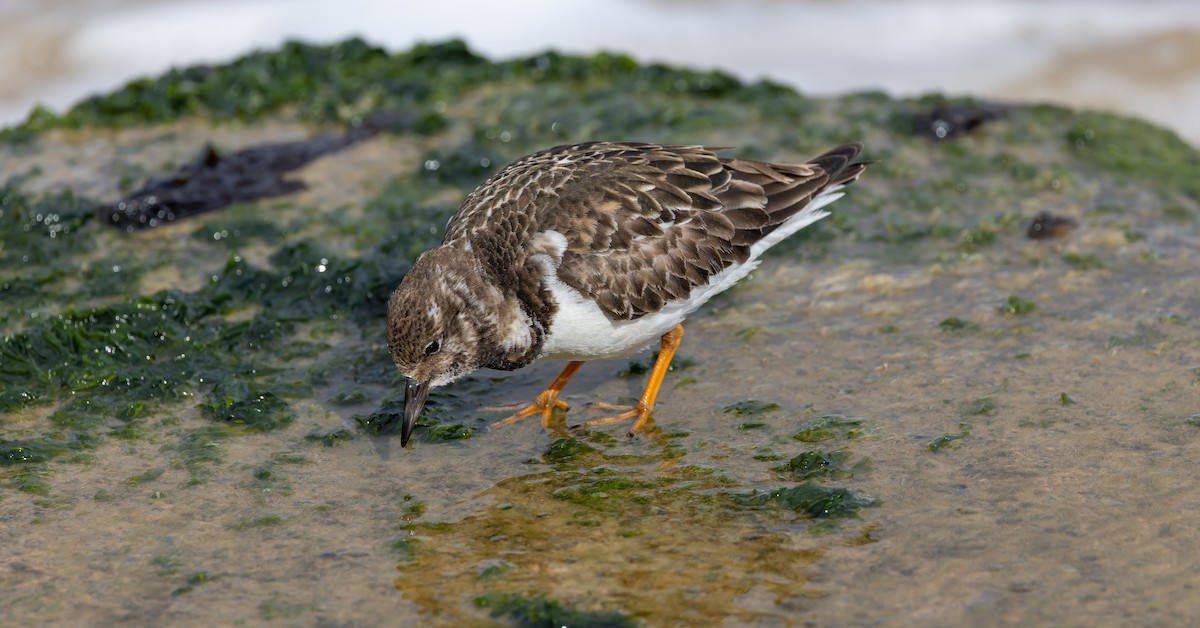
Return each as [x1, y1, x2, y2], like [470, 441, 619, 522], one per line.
[0, 40, 796, 147]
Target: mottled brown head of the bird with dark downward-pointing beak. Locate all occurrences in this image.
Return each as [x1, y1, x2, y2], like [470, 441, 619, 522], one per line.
[388, 249, 492, 447]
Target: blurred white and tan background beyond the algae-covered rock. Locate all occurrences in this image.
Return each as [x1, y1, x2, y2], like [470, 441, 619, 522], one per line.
[7, 0, 1200, 145]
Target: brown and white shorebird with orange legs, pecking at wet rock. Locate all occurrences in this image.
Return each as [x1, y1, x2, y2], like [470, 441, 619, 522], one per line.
[386, 142, 870, 447]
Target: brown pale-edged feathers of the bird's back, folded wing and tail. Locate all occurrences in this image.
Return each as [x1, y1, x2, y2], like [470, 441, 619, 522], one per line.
[446, 143, 865, 319]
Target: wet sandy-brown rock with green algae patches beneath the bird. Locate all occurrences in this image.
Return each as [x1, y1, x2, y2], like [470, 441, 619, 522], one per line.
[0, 41, 1200, 626]
